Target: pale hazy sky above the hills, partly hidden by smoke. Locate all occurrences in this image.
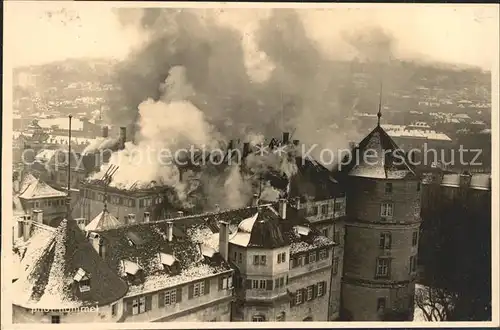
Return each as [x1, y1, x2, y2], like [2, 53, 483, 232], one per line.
[4, 2, 499, 69]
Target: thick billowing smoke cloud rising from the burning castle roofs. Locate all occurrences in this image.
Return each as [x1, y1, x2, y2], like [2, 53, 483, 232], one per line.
[102, 9, 406, 208]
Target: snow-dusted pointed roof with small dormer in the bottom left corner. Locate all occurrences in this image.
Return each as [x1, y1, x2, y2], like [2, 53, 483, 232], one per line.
[13, 219, 127, 309]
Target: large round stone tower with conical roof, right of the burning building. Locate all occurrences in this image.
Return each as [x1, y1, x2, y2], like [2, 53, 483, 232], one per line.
[338, 125, 421, 321]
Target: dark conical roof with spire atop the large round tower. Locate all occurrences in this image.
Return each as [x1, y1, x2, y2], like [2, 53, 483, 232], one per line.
[339, 125, 415, 179]
